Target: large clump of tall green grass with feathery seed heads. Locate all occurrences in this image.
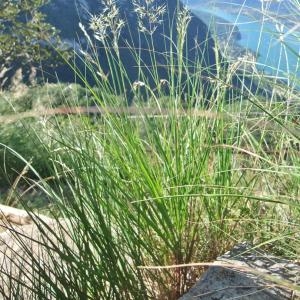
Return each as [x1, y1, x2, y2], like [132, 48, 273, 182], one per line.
[2, 1, 300, 299]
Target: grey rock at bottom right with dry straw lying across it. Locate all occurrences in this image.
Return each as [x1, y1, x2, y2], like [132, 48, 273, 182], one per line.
[180, 243, 300, 300]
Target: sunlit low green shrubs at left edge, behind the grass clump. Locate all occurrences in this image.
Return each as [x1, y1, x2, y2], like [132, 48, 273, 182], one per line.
[0, 84, 94, 197]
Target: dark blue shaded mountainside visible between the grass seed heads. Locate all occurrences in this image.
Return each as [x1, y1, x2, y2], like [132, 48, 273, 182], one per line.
[44, 0, 215, 96]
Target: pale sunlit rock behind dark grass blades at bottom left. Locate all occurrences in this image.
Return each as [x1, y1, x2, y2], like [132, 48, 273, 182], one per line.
[0, 216, 76, 300]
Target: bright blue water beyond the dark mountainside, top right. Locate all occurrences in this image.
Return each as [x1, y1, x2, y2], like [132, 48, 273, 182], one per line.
[186, 0, 300, 86]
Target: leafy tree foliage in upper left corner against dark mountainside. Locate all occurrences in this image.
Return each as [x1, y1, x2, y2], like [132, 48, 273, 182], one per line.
[0, 0, 67, 88]
